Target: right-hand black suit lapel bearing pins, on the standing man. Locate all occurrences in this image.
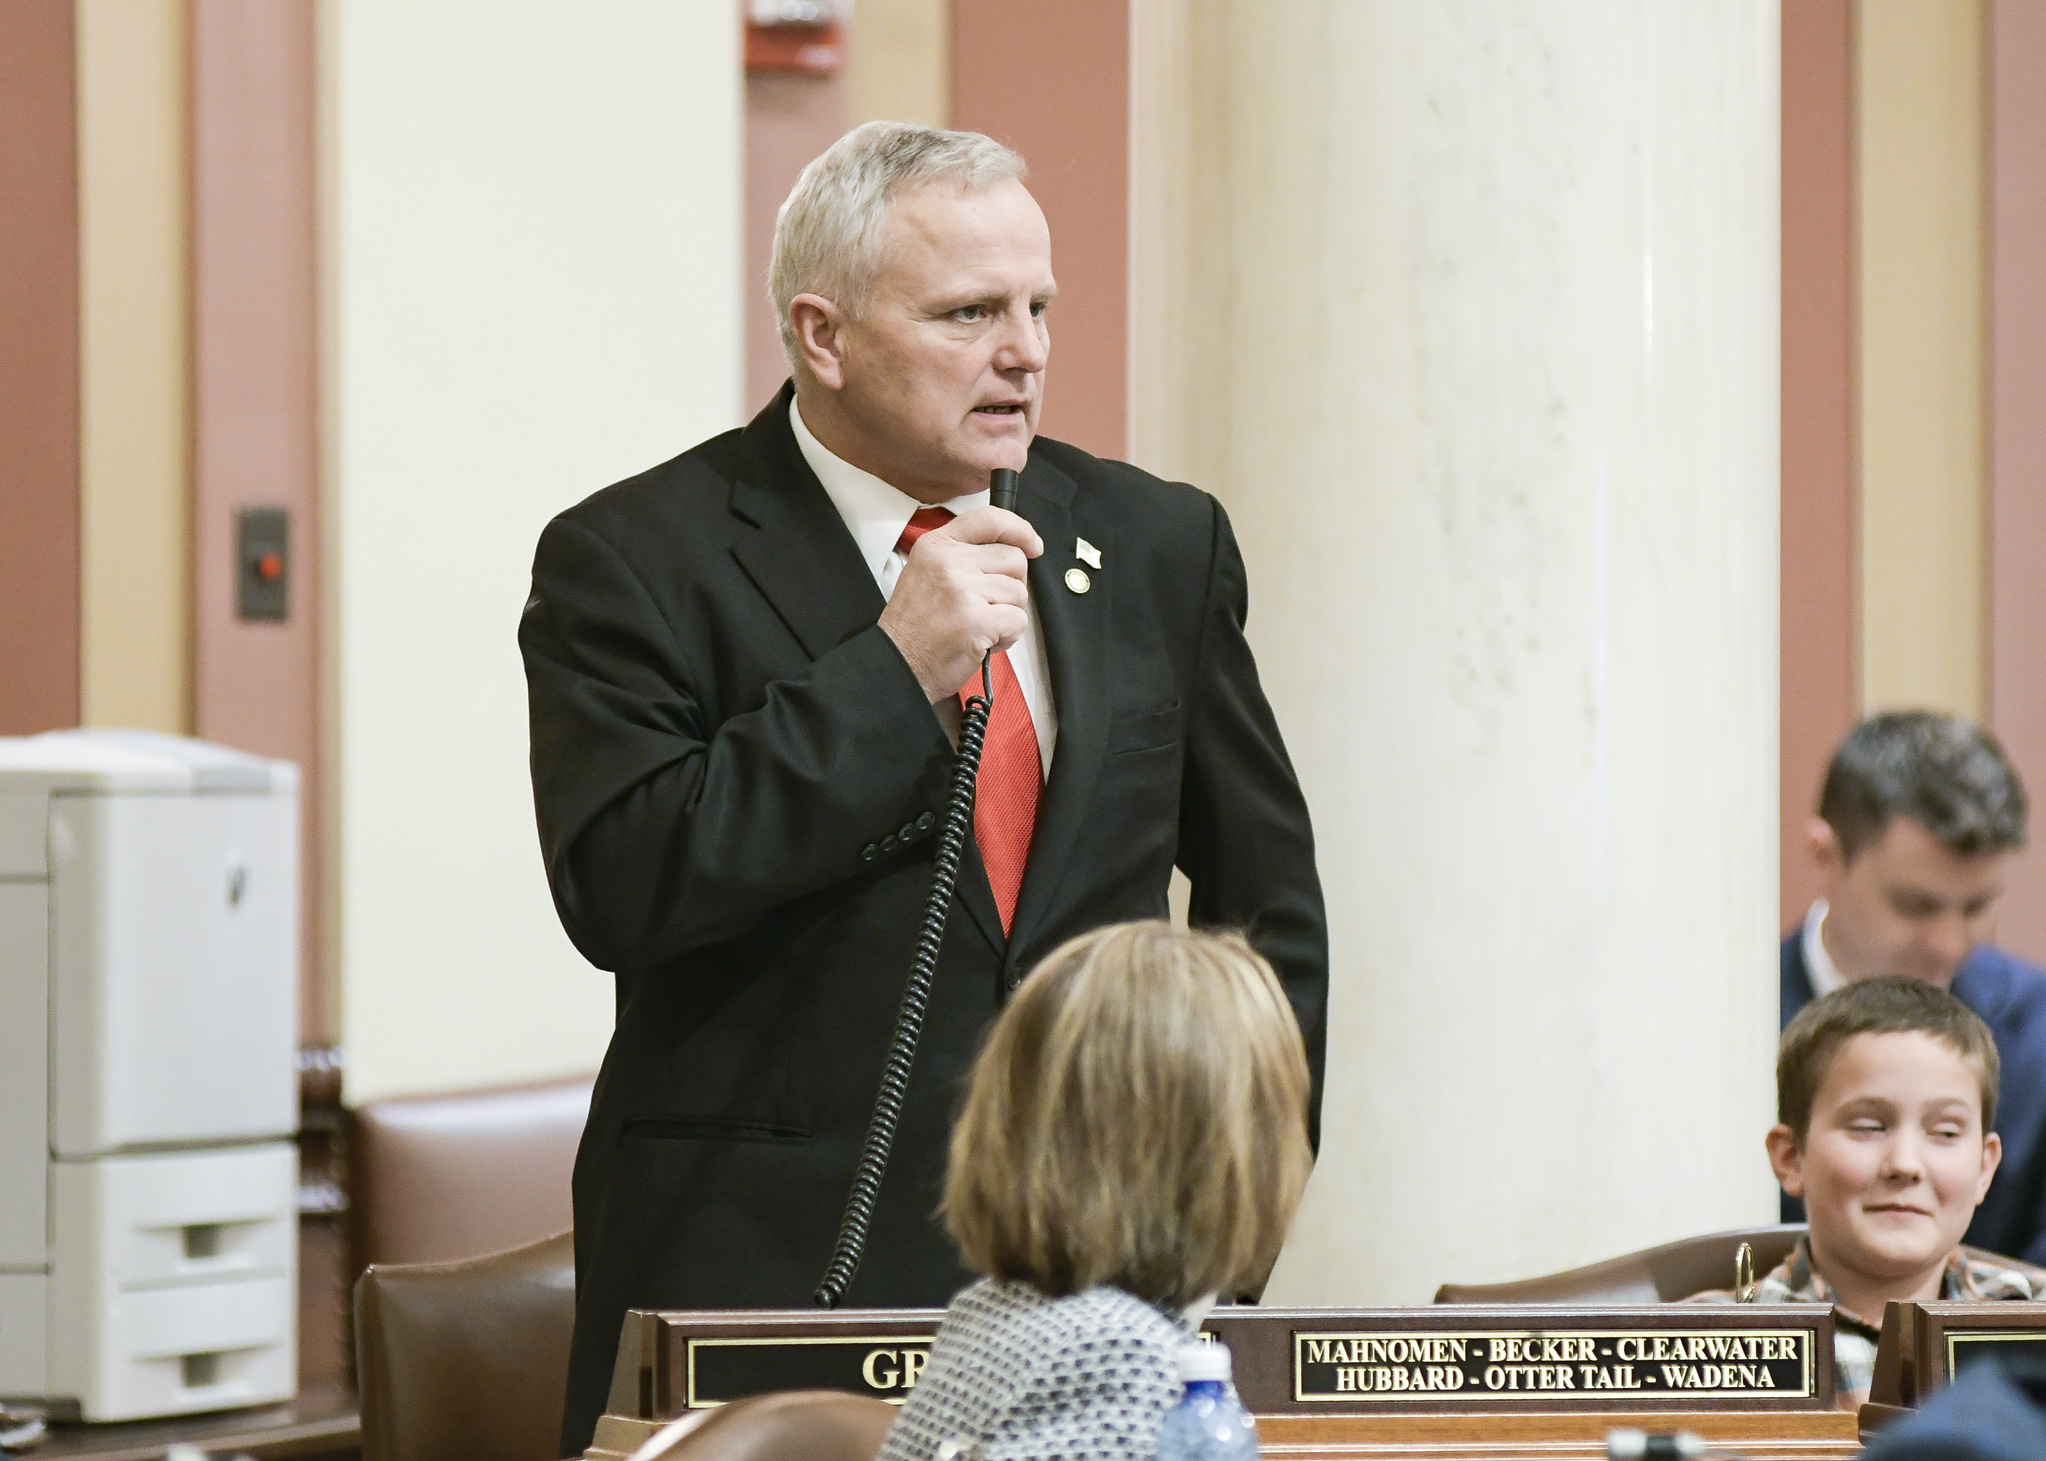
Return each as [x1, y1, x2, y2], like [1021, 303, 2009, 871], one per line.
[1003, 456, 1115, 978]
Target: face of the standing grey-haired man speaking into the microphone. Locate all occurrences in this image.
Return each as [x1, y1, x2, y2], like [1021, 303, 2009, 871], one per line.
[818, 182, 1056, 501]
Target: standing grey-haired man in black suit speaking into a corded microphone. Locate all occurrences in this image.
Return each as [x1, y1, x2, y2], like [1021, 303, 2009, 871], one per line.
[520, 123, 1328, 1453]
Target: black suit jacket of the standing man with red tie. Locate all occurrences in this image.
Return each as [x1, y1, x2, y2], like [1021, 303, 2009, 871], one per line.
[520, 387, 1328, 1455]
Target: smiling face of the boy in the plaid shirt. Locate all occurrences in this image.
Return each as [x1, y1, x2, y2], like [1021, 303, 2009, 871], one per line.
[1768, 1031, 2003, 1285]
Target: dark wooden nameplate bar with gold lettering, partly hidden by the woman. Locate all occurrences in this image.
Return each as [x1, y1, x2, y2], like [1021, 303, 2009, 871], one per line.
[610, 1303, 1841, 1420]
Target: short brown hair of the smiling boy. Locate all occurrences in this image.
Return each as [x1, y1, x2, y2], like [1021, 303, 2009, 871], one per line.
[1776, 974, 1999, 1146]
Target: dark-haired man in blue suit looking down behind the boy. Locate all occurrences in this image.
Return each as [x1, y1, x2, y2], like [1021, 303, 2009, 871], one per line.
[1782, 710, 2046, 1263]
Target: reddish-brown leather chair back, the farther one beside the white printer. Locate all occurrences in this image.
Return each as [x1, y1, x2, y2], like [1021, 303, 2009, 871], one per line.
[348, 1078, 593, 1277]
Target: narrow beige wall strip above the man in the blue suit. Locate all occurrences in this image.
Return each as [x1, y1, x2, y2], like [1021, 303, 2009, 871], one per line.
[1856, 0, 1985, 716]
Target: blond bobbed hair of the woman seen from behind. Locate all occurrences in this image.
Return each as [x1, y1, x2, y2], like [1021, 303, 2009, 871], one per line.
[939, 923, 1314, 1305]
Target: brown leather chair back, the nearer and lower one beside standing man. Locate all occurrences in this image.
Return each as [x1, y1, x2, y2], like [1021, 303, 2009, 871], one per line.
[356, 1232, 575, 1461]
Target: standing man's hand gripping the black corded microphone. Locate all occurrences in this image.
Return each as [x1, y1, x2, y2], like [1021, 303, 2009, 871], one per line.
[882, 507, 1043, 706]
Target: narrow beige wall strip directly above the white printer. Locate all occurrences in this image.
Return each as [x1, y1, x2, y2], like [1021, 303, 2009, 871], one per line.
[78, 0, 190, 733]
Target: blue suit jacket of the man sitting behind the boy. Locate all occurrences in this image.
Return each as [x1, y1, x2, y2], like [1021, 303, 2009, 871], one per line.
[1782, 929, 2046, 1265]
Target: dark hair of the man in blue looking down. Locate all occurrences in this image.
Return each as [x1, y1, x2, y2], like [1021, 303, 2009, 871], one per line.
[1819, 710, 2026, 861]
